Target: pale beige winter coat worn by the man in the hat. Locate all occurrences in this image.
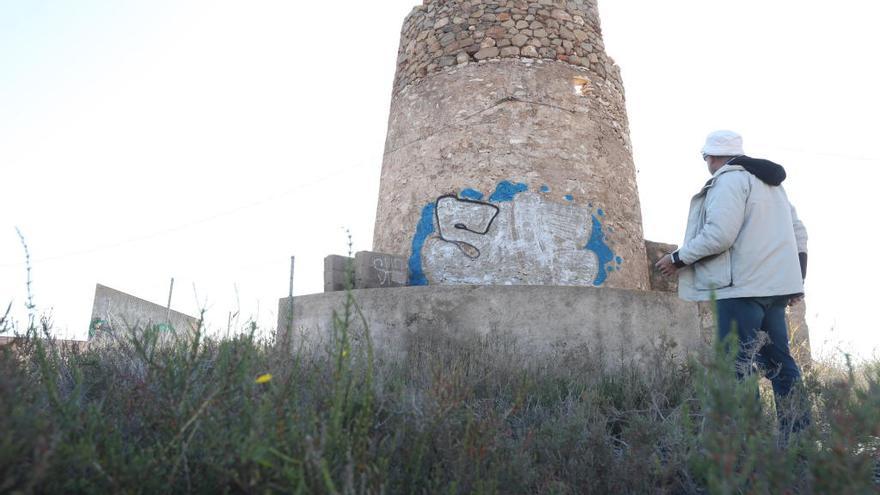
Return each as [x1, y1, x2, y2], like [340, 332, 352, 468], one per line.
[677, 165, 807, 301]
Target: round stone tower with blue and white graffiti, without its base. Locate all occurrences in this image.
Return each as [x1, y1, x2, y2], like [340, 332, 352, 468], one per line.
[374, 0, 649, 290]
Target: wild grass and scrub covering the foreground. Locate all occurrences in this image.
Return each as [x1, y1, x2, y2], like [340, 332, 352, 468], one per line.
[0, 294, 880, 494]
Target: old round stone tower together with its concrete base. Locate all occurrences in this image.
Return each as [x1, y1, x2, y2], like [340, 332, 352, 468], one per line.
[278, 0, 808, 360]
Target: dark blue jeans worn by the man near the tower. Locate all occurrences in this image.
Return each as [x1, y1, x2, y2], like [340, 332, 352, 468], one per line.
[717, 296, 810, 437]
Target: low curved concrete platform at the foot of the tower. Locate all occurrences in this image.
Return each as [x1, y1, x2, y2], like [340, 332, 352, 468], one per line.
[277, 286, 712, 360]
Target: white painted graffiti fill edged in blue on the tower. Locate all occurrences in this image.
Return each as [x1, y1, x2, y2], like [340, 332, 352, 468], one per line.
[422, 192, 599, 286]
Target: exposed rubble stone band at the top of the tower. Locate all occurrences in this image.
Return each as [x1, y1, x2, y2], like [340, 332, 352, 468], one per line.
[394, 0, 622, 93]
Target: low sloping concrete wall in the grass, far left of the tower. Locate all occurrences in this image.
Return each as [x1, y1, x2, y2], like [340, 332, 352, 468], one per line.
[89, 284, 199, 337]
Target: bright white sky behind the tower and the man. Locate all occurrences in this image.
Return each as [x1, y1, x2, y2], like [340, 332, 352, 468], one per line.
[0, 0, 880, 362]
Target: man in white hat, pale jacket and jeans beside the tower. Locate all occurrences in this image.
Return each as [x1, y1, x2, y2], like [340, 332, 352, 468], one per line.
[657, 131, 809, 434]
